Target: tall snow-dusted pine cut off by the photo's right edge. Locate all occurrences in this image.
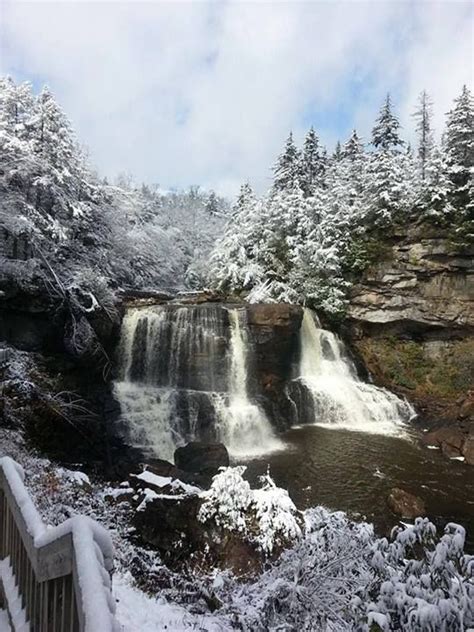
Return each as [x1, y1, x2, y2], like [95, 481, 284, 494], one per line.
[445, 86, 474, 212]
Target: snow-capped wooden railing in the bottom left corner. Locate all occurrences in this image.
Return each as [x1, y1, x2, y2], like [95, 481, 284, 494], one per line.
[0, 457, 117, 632]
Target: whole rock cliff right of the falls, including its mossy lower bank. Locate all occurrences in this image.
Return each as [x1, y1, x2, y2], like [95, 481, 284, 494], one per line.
[348, 225, 474, 434]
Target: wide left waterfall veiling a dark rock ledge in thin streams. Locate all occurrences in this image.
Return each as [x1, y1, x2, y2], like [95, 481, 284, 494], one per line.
[114, 305, 281, 460]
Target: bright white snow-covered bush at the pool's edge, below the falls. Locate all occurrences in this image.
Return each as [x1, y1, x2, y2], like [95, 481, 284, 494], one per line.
[198, 465, 302, 555]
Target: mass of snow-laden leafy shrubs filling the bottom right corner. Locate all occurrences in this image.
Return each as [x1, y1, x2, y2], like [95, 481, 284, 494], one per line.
[227, 507, 474, 632]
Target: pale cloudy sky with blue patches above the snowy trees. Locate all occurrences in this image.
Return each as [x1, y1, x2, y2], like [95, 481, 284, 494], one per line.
[0, 0, 474, 195]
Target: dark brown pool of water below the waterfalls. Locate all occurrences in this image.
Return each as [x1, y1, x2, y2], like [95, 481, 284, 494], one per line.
[237, 426, 474, 552]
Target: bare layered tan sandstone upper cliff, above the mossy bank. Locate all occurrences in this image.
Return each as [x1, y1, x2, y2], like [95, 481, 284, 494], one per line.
[349, 225, 474, 338]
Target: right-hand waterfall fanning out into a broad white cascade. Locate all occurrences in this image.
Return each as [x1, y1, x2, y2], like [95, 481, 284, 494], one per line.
[297, 309, 414, 434]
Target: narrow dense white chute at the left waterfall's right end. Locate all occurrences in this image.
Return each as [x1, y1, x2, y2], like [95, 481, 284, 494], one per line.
[218, 309, 283, 456]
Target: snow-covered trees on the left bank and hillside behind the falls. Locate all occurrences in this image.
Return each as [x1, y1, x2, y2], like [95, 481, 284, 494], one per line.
[0, 77, 228, 296]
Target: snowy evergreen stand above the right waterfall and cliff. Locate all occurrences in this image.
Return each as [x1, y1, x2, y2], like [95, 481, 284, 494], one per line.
[209, 88, 474, 314]
